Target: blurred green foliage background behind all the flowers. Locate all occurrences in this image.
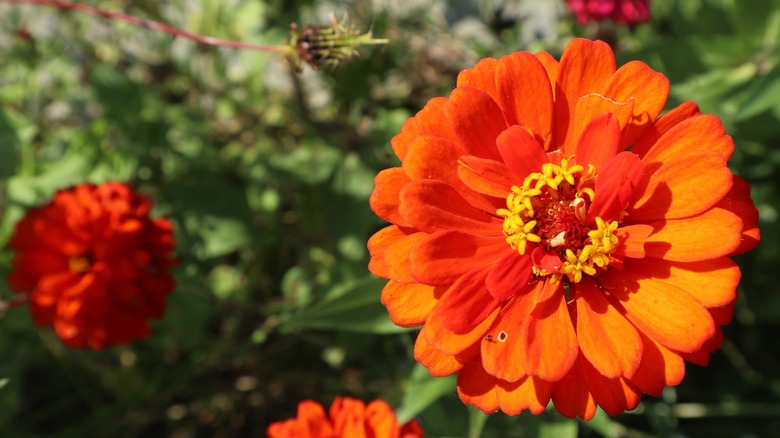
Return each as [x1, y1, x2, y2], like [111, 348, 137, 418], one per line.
[0, 0, 780, 437]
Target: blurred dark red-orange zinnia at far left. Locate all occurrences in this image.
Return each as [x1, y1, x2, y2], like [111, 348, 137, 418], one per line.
[8, 183, 175, 350]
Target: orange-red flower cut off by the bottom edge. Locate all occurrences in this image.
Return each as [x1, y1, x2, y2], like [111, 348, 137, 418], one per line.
[266, 397, 423, 438]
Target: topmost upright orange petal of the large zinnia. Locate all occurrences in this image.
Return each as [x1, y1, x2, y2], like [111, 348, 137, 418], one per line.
[552, 38, 615, 156]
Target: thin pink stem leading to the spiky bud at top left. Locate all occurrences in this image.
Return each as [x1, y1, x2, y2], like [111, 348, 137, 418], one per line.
[0, 0, 290, 53]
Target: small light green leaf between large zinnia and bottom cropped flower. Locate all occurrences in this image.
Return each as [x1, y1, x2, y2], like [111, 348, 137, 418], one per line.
[396, 363, 455, 423]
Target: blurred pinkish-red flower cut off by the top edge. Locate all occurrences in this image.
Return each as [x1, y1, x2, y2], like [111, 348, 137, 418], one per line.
[566, 0, 650, 24]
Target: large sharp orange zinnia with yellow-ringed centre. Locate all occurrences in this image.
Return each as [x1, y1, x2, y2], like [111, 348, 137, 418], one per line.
[368, 39, 759, 419]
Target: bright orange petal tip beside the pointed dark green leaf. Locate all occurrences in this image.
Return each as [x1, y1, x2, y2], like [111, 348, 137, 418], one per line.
[382, 280, 444, 327]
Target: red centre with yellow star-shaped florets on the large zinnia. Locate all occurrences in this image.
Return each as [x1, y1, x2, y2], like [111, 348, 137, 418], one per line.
[496, 159, 618, 283]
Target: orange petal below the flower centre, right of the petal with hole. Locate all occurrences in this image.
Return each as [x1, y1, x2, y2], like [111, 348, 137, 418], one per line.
[519, 280, 578, 382]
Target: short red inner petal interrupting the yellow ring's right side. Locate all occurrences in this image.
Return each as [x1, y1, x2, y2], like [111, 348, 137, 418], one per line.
[586, 152, 642, 224]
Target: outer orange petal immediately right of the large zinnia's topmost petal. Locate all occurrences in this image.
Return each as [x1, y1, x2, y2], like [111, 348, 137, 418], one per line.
[601, 61, 669, 150]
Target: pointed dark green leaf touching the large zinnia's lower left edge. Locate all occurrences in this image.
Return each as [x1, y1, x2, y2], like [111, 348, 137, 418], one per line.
[279, 276, 408, 334]
